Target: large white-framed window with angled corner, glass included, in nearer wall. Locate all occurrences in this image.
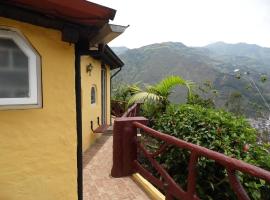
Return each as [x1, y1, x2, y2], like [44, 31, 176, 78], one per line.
[0, 27, 41, 109]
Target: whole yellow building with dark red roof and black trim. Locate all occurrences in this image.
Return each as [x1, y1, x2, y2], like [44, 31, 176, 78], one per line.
[0, 0, 126, 200]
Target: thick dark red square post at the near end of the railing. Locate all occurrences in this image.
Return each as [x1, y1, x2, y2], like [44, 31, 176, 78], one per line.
[111, 117, 148, 178]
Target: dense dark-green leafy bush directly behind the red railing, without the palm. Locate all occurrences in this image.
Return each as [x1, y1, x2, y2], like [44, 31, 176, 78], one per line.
[153, 104, 270, 200]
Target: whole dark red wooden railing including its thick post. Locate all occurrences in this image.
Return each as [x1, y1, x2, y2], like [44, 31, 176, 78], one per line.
[112, 105, 270, 200]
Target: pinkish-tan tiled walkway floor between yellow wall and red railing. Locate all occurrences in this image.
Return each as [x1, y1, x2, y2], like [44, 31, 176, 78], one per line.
[83, 135, 149, 200]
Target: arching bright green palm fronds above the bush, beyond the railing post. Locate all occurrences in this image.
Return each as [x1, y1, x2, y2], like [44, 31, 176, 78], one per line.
[128, 76, 194, 111]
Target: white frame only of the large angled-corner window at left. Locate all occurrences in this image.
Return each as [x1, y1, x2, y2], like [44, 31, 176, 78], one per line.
[0, 26, 42, 110]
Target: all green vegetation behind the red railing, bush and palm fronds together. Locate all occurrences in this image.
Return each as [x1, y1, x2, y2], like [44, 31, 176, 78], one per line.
[111, 76, 270, 200]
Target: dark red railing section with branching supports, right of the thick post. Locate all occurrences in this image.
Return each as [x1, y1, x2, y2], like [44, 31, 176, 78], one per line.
[133, 122, 270, 200]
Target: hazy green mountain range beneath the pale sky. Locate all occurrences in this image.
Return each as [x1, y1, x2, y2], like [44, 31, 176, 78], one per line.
[113, 42, 270, 115]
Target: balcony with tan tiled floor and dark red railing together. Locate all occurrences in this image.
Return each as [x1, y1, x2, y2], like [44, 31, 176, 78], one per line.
[84, 104, 270, 200]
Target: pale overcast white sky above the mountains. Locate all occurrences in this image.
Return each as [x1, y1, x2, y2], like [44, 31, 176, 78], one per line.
[90, 0, 270, 48]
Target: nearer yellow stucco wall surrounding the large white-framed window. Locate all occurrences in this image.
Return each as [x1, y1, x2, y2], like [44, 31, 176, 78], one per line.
[0, 18, 77, 200]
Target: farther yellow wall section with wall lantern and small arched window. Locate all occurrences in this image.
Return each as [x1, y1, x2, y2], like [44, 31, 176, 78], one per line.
[81, 56, 110, 151]
